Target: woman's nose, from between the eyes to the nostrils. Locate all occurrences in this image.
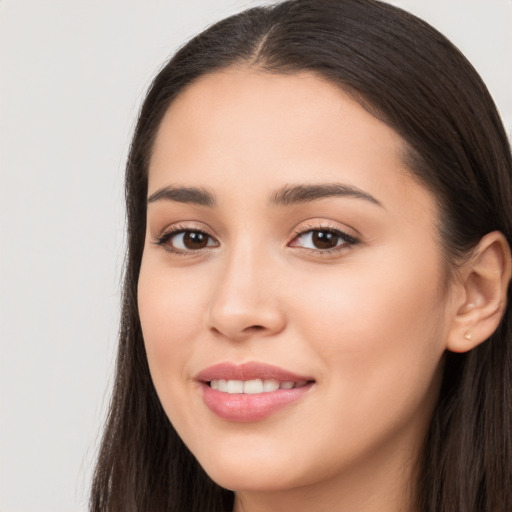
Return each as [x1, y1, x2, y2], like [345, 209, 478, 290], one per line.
[208, 243, 286, 341]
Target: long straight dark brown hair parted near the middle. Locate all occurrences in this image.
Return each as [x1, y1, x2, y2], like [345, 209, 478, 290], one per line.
[90, 0, 512, 512]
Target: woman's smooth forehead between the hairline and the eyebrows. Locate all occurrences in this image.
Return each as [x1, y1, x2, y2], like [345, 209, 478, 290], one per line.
[149, 68, 436, 216]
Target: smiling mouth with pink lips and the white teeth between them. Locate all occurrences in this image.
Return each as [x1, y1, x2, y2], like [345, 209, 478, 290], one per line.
[195, 363, 315, 422]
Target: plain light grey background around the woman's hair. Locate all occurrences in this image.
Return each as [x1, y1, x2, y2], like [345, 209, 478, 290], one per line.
[0, 0, 512, 512]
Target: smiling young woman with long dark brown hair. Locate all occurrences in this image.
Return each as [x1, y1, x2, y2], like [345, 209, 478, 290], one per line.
[91, 0, 512, 512]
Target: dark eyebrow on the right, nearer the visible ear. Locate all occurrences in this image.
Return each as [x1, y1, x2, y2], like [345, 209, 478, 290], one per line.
[270, 183, 384, 208]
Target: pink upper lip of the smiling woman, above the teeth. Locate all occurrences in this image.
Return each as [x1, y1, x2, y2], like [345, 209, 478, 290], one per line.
[195, 362, 314, 382]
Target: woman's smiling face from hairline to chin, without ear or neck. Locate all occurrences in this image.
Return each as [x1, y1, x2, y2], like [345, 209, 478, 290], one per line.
[138, 69, 451, 491]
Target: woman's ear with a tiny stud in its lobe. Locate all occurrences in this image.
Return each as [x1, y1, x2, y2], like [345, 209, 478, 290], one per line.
[446, 231, 512, 352]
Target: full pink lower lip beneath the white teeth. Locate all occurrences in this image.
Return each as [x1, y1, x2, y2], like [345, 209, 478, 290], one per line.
[201, 383, 313, 422]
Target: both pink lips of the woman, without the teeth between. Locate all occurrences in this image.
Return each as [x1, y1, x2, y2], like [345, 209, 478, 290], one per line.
[196, 362, 314, 422]
